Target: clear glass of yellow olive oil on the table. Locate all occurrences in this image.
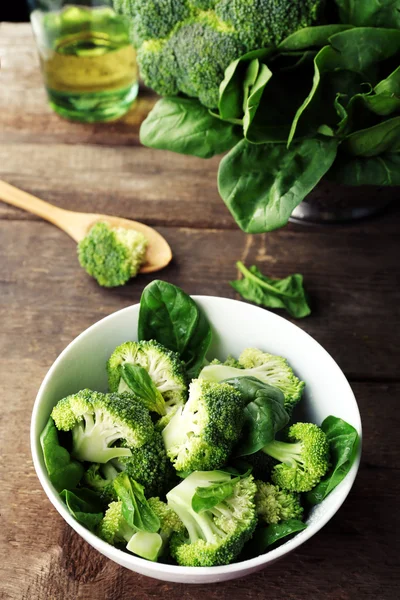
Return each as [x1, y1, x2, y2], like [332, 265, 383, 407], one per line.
[31, 5, 139, 122]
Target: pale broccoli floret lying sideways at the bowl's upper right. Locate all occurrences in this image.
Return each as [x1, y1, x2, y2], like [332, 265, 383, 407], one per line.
[199, 348, 305, 415]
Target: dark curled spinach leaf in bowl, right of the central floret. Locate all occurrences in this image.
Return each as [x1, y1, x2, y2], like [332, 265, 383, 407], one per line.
[225, 377, 289, 456]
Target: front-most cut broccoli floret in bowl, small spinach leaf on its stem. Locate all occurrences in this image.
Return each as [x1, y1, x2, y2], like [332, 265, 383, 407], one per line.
[167, 471, 257, 567]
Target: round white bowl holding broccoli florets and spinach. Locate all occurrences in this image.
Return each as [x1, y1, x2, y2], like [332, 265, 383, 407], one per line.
[31, 296, 361, 583]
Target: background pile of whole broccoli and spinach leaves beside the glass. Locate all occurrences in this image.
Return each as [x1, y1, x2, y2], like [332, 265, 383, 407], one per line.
[129, 0, 400, 233]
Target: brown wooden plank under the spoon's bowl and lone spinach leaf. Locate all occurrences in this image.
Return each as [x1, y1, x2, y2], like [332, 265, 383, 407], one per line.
[0, 221, 400, 380]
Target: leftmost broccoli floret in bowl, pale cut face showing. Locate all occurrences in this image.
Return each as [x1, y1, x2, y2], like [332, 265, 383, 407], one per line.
[51, 390, 154, 463]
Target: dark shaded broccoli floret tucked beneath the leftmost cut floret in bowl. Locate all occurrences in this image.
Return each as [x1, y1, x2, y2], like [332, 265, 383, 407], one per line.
[84, 431, 175, 500]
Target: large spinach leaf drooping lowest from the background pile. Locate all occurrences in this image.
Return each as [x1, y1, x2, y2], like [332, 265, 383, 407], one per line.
[218, 138, 338, 233]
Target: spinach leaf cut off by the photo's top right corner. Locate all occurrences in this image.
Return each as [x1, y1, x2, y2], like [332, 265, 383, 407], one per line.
[335, 0, 400, 29]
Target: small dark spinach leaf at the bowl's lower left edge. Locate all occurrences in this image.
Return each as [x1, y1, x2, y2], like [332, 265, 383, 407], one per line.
[60, 488, 104, 532]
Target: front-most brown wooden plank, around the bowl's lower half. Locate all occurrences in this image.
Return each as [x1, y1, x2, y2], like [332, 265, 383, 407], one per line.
[0, 380, 400, 600]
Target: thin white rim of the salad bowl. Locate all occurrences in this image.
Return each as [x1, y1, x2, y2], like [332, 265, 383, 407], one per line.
[30, 294, 362, 578]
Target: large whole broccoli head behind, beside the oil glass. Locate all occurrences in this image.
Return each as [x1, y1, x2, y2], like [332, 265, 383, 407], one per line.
[114, 0, 324, 108]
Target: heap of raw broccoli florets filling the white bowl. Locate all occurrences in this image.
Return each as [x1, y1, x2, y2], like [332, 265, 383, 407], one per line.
[43, 330, 340, 567]
